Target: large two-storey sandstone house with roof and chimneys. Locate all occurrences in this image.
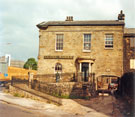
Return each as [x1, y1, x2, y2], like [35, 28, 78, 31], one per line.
[37, 12, 125, 81]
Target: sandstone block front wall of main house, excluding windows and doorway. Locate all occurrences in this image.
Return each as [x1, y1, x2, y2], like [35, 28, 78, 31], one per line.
[37, 26, 123, 77]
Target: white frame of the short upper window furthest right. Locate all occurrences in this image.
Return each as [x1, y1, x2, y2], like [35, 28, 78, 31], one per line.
[104, 34, 114, 49]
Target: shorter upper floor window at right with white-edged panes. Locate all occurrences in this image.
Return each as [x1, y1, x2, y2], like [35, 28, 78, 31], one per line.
[105, 34, 113, 48]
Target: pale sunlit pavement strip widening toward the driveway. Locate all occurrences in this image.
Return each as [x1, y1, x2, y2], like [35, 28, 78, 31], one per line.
[0, 87, 108, 117]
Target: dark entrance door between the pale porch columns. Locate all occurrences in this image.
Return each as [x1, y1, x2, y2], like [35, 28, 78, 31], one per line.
[82, 63, 89, 82]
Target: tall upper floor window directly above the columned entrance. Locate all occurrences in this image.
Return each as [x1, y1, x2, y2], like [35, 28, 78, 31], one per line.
[83, 34, 91, 51]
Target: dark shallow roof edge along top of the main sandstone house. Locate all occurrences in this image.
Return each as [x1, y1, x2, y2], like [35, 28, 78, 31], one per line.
[37, 20, 125, 29]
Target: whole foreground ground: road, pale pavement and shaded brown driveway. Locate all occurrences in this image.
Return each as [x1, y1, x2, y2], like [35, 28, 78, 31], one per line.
[0, 87, 132, 117]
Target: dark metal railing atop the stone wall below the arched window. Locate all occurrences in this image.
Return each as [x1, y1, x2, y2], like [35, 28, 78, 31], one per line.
[34, 73, 95, 83]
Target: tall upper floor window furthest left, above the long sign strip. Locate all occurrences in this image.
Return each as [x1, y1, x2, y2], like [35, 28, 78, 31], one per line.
[56, 34, 64, 51]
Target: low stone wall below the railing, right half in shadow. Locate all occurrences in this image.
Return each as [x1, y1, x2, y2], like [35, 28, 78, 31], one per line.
[31, 80, 96, 98]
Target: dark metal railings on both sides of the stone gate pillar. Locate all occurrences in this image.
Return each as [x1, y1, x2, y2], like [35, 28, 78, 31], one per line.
[11, 73, 95, 85]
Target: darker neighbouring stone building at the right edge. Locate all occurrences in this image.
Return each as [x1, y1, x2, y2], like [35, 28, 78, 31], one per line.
[124, 28, 135, 73]
